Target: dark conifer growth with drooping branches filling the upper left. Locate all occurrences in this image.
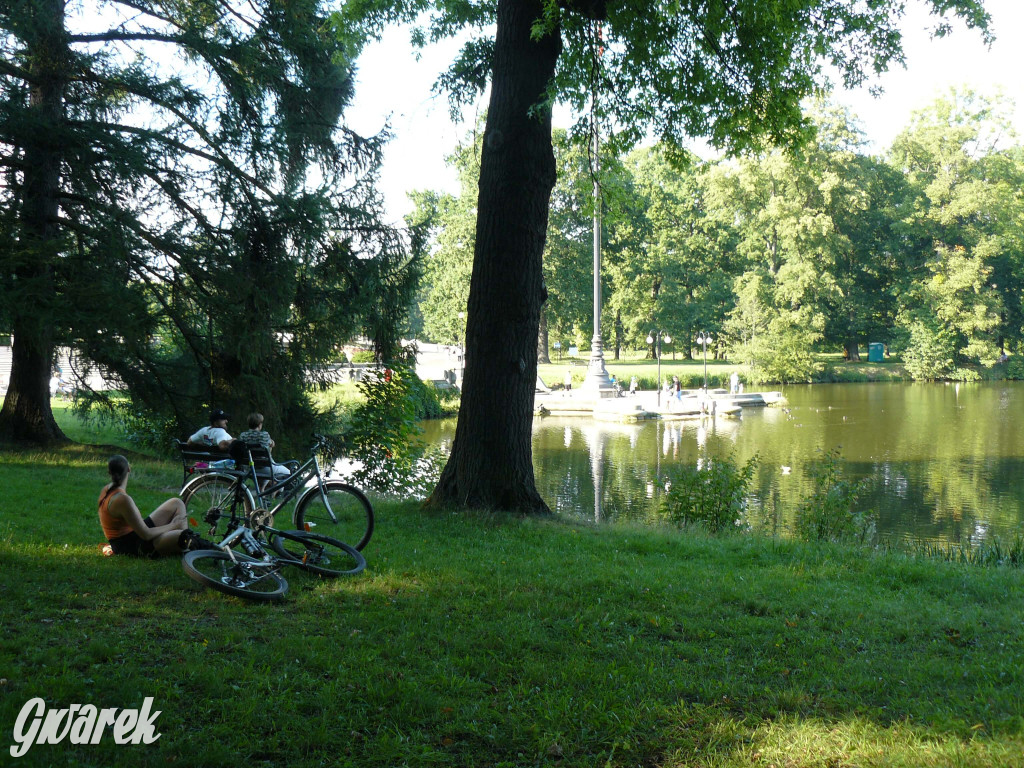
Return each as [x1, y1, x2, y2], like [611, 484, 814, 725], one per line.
[0, 0, 413, 442]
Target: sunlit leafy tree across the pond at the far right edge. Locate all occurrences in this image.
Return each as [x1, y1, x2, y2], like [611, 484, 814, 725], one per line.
[890, 91, 1024, 368]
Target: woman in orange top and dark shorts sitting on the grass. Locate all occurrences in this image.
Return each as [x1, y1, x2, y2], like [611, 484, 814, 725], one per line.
[99, 456, 214, 557]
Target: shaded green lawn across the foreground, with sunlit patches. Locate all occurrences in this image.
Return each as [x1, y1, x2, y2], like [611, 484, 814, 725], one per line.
[0, 438, 1024, 768]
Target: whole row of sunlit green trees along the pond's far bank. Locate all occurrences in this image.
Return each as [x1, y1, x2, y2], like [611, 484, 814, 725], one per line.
[411, 91, 1024, 381]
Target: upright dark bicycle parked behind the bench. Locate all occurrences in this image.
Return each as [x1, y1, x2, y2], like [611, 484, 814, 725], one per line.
[180, 435, 374, 551]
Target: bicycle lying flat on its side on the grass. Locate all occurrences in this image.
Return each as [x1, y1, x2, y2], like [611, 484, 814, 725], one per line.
[181, 519, 367, 601]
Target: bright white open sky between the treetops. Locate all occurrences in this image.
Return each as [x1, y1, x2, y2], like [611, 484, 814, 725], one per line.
[345, 0, 1024, 221]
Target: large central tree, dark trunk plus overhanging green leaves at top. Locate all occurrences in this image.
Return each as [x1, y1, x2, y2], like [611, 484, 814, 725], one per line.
[348, 0, 988, 512]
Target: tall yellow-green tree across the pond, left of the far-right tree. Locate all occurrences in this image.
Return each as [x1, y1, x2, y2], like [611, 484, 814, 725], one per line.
[711, 102, 903, 381]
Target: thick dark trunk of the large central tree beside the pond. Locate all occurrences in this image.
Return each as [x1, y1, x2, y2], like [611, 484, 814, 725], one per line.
[428, 0, 561, 513]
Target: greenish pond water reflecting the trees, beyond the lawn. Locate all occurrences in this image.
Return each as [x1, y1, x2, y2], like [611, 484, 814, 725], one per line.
[425, 382, 1024, 544]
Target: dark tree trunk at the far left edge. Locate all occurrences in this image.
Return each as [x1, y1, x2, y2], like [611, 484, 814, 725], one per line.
[0, 0, 68, 444]
